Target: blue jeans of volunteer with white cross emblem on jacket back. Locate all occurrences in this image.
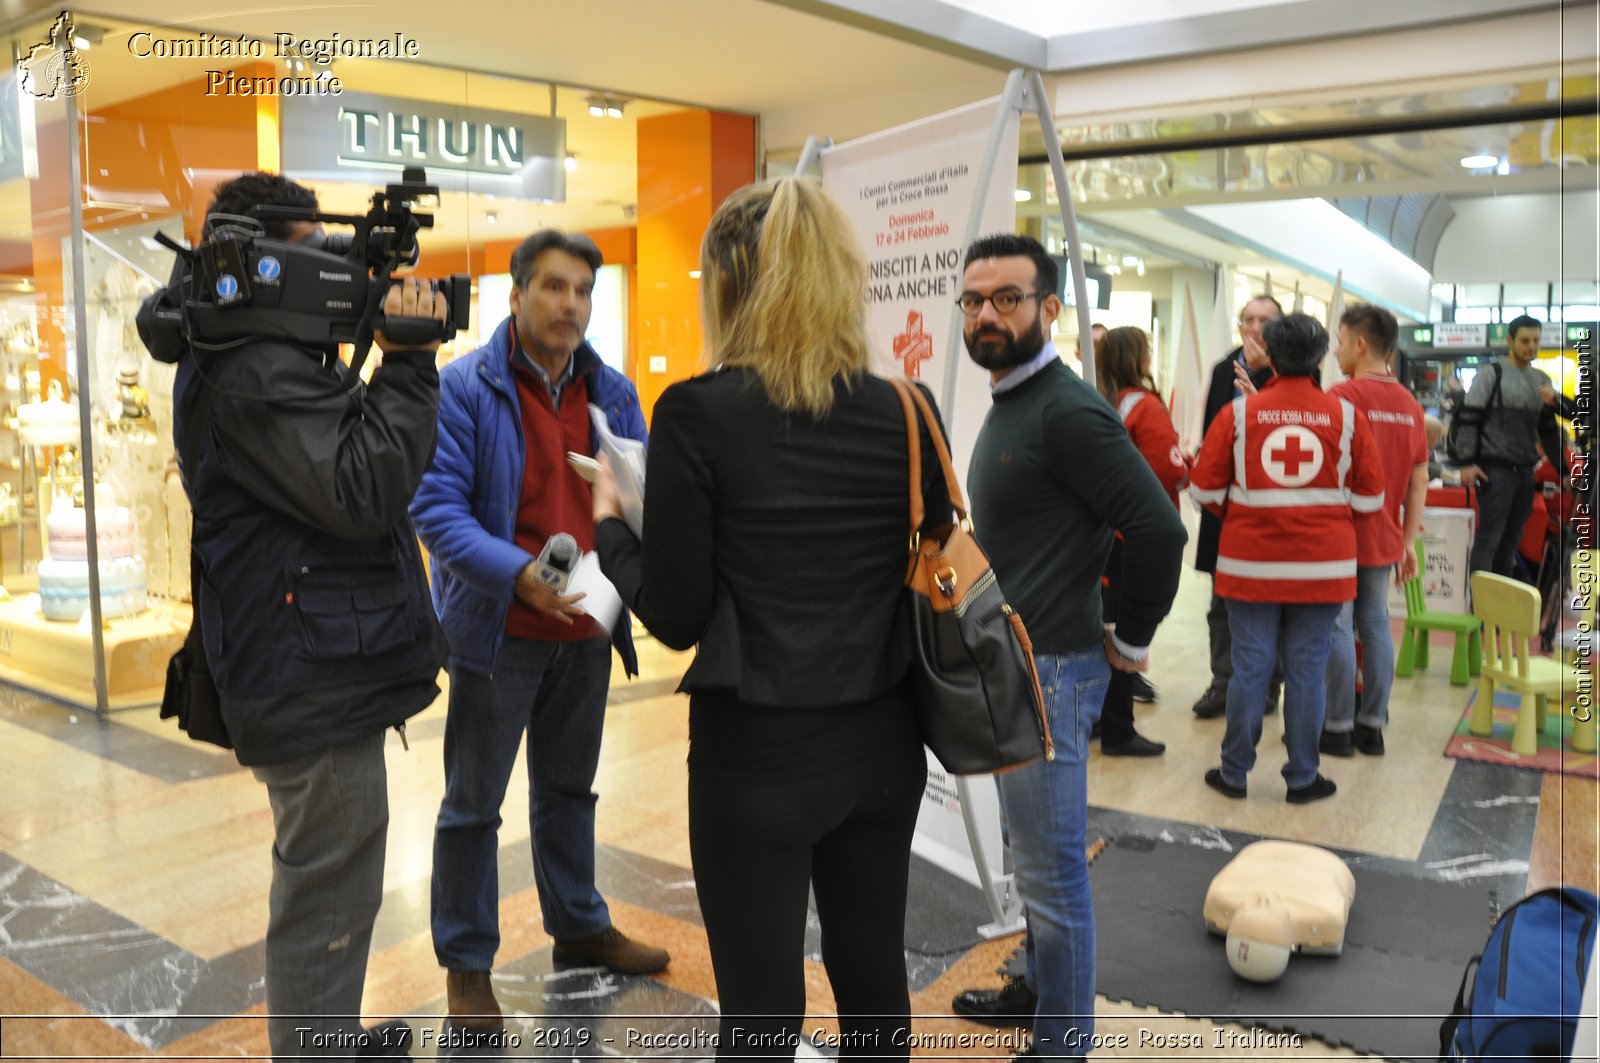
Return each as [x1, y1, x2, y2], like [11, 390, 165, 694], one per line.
[1222, 599, 1339, 789]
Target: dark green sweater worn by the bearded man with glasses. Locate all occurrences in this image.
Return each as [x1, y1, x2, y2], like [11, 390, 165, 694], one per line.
[966, 362, 1187, 653]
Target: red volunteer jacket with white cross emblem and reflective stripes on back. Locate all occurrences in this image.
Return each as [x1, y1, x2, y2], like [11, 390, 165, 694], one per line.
[1189, 376, 1384, 604]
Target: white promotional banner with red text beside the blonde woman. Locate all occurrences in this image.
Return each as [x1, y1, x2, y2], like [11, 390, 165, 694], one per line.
[821, 98, 1019, 885]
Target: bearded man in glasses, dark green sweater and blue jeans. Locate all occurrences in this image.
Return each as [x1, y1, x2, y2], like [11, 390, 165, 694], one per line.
[952, 234, 1187, 1058]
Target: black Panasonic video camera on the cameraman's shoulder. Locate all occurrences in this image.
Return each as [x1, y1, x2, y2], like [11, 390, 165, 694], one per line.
[139, 168, 472, 377]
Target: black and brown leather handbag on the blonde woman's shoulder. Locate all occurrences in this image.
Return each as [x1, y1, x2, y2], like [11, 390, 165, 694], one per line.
[890, 379, 1056, 775]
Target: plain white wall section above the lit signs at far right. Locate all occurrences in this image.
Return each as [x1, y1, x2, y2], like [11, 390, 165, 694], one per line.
[1434, 191, 1600, 283]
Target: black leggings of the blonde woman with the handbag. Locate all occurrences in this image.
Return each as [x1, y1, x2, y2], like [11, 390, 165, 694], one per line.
[690, 687, 926, 1063]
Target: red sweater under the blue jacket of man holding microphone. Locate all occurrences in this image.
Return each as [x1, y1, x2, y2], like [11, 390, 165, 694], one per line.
[506, 338, 605, 642]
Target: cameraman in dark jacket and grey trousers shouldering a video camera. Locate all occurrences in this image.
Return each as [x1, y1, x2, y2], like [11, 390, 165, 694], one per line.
[141, 173, 446, 1061]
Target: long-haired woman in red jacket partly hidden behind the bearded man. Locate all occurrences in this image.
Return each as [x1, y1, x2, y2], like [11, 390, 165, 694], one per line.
[1094, 327, 1189, 757]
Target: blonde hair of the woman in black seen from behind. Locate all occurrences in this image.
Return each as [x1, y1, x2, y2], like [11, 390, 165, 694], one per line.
[701, 178, 872, 416]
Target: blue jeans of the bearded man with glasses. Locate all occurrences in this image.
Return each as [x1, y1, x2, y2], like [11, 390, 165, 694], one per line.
[998, 645, 1110, 1060]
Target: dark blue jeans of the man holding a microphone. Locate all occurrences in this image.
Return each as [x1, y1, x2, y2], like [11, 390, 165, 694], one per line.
[432, 639, 611, 970]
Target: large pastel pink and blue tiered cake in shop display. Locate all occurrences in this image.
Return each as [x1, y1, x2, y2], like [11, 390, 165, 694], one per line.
[38, 498, 149, 621]
